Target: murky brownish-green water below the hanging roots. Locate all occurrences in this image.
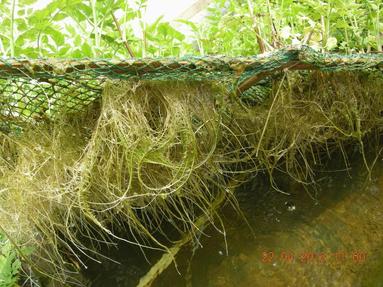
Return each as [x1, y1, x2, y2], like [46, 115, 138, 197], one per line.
[85, 152, 383, 287]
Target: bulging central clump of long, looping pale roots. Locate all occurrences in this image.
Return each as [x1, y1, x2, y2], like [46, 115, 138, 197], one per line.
[74, 83, 224, 237]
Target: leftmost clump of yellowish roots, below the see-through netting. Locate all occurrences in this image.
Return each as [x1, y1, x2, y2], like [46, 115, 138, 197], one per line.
[0, 114, 95, 282]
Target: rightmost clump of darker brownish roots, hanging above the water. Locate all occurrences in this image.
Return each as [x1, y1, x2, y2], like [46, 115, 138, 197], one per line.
[228, 72, 383, 186]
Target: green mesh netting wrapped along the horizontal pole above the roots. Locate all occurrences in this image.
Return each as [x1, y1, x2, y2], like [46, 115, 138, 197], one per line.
[0, 46, 383, 129]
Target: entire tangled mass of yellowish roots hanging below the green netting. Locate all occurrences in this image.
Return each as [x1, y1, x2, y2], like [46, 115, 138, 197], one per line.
[0, 72, 383, 283]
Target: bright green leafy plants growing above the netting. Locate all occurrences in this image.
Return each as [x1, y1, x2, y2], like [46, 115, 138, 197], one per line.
[0, 0, 383, 58]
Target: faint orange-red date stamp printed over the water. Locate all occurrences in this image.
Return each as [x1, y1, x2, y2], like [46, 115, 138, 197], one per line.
[261, 250, 367, 264]
